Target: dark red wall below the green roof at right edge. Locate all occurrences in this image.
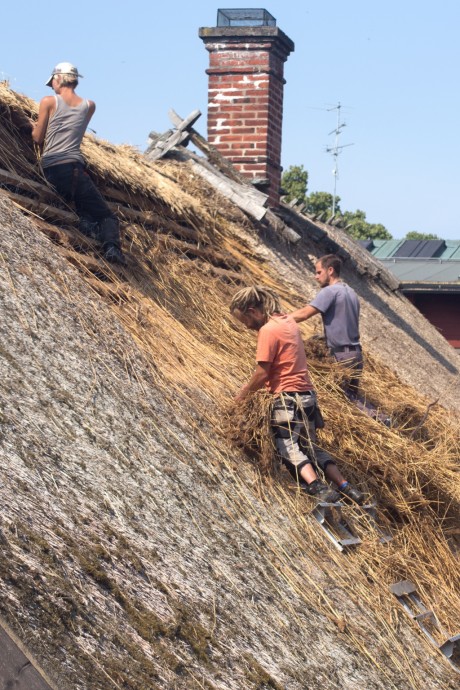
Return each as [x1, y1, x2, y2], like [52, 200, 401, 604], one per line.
[404, 292, 460, 348]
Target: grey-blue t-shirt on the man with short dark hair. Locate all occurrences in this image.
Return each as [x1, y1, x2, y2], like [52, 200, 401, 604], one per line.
[310, 281, 359, 348]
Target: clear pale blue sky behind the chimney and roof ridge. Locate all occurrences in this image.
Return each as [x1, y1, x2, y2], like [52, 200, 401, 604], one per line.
[0, 0, 460, 239]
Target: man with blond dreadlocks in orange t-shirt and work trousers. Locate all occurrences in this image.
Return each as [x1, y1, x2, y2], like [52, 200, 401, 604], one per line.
[230, 286, 364, 504]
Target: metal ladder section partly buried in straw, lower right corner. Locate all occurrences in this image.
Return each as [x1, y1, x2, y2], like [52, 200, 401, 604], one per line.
[390, 580, 460, 673]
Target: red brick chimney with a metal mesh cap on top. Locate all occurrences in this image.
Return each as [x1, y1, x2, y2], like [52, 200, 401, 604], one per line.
[199, 9, 294, 207]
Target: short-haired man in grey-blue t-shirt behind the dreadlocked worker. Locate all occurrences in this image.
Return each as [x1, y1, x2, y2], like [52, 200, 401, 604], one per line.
[291, 254, 390, 426]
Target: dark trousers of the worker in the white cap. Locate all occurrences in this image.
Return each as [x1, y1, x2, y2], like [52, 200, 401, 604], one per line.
[43, 163, 120, 248]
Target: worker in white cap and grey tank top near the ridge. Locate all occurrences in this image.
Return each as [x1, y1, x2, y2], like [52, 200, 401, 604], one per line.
[32, 62, 126, 265]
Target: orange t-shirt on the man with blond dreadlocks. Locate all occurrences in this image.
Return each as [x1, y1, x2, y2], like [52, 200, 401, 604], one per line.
[256, 314, 313, 393]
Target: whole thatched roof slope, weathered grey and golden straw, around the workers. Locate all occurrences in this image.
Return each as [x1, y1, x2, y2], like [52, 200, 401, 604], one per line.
[0, 87, 460, 690]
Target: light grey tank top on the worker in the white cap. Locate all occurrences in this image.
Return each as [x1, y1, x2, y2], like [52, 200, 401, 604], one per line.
[41, 96, 89, 168]
